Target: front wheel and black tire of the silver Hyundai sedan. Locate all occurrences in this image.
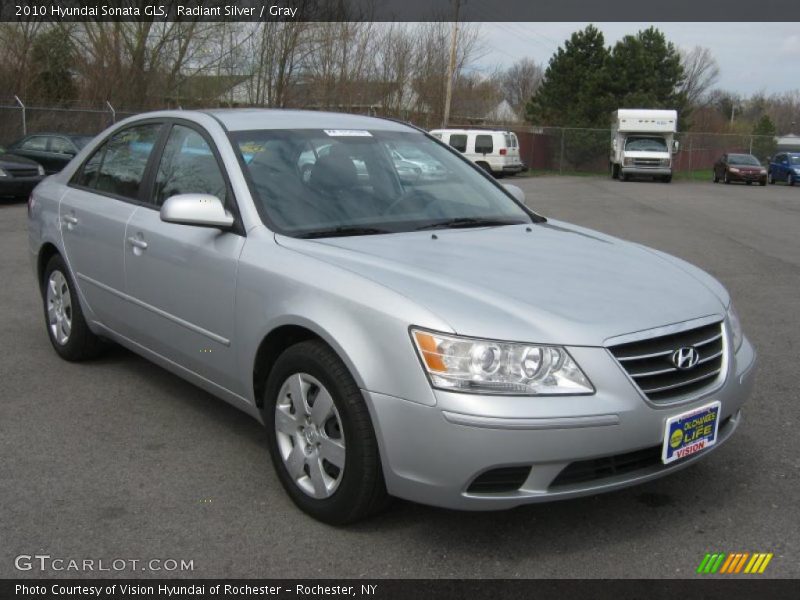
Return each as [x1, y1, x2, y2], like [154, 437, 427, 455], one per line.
[262, 340, 389, 525]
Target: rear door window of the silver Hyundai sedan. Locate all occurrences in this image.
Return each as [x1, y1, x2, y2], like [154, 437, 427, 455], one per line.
[94, 123, 161, 200]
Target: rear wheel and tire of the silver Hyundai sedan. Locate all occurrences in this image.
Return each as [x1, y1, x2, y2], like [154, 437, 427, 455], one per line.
[42, 254, 104, 361]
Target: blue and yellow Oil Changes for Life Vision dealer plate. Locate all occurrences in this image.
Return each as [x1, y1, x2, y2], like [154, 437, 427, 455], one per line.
[661, 402, 720, 464]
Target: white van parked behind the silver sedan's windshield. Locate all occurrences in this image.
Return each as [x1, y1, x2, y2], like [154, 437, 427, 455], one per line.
[430, 129, 525, 177]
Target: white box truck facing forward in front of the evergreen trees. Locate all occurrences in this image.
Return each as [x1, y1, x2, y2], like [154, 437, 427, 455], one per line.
[610, 108, 678, 183]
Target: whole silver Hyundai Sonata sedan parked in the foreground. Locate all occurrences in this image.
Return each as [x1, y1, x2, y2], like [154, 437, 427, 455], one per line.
[29, 110, 755, 523]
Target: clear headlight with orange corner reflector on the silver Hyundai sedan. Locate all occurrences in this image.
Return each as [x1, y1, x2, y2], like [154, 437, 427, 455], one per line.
[411, 329, 594, 396]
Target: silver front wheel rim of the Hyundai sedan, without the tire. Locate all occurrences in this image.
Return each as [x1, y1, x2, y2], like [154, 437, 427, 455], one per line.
[275, 373, 345, 499]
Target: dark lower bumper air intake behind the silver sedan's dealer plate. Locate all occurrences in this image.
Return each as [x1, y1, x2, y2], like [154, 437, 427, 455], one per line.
[549, 417, 731, 489]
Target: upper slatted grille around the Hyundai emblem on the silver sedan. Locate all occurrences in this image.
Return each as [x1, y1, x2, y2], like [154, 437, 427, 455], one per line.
[609, 323, 724, 402]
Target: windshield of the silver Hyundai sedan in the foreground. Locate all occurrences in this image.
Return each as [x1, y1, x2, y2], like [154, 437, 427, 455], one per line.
[231, 130, 532, 237]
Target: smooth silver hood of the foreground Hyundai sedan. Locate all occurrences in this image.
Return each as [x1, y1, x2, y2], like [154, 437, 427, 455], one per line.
[276, 220, 727, 345]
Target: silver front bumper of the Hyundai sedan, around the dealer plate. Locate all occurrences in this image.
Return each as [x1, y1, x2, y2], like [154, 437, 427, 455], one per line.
[365, 339, 755, 510]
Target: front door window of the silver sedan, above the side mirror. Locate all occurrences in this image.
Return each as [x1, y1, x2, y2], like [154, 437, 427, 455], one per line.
[154, 125, 227, 206]
